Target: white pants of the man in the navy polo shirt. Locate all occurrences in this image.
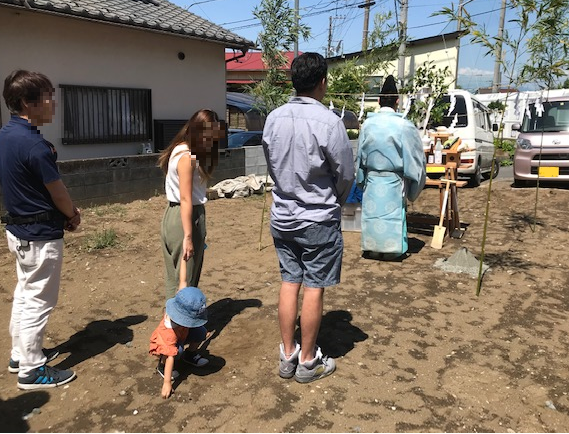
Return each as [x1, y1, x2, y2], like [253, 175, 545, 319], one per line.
[6, 231, 63, 377]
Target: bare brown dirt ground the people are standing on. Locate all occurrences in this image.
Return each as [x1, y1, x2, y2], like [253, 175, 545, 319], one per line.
[0, 181, 569, 432]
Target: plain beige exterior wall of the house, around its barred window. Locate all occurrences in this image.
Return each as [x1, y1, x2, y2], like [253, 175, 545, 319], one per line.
[0, 7, 226, 160]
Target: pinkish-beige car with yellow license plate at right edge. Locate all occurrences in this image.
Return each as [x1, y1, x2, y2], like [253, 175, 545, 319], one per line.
[512, 91, 569, 187]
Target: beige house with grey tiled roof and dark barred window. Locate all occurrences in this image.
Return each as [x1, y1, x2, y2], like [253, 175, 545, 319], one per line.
[0, 0, 254, 160]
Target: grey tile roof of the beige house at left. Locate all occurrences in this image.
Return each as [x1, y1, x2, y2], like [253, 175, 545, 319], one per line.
[0, 0, 255, 48]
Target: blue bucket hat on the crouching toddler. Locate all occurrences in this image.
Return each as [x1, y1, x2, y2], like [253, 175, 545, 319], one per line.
[166, 286, 207, 328]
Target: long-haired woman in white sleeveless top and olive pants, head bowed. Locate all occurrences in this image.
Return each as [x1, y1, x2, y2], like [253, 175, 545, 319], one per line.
[158, 109, 225, 299]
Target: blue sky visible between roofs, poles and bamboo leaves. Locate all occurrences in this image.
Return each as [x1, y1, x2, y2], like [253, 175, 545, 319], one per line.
[174, 0, 528, 90]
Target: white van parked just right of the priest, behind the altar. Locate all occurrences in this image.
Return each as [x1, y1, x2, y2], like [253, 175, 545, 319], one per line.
[431, 89, 500, 186]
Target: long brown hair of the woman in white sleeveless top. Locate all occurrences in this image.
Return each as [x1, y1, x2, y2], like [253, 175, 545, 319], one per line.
[158, 109, 225, 179]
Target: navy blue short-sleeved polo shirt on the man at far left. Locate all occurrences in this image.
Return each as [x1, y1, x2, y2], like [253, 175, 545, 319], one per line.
[0, 116, 65, 241]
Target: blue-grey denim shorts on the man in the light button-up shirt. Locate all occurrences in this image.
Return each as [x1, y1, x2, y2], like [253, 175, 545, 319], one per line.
[271, 222, 344, 288]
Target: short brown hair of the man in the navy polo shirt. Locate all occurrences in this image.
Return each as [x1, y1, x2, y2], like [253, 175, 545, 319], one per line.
[2, 69, 53, 115]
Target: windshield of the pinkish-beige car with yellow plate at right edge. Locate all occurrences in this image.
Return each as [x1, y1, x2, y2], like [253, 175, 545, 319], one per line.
[522, 101, 569, 133]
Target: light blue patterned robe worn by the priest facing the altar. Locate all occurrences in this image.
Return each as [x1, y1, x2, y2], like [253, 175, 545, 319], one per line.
[356, 108, 426, 254]
